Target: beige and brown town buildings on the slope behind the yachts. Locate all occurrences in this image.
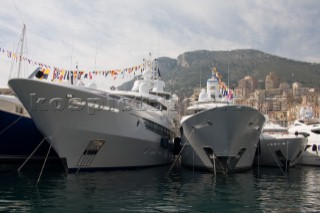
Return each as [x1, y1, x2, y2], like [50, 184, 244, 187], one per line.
[234, 72, 320, 126]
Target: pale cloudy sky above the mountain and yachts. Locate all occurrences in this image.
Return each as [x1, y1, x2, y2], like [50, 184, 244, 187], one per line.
[0, 0, 320, 87]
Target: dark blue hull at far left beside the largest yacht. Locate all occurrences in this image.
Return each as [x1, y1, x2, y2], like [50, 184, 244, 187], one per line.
[0, 110, 59, 162]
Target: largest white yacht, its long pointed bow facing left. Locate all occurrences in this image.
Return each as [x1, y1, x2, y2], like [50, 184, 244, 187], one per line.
[9, 56, 177, 171]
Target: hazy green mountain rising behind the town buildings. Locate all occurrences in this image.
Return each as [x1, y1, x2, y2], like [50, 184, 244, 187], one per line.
[119, 49, 320, 98]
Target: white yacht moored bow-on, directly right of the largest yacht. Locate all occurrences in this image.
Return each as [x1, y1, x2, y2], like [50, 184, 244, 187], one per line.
[180, 68, 265, 173]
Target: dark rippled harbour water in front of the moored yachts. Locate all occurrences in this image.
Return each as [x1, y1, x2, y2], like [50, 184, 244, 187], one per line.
[0, 162, 320, 213]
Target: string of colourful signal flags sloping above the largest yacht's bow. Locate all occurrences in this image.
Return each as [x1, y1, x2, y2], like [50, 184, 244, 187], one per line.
[0, 47, 144, 81]
